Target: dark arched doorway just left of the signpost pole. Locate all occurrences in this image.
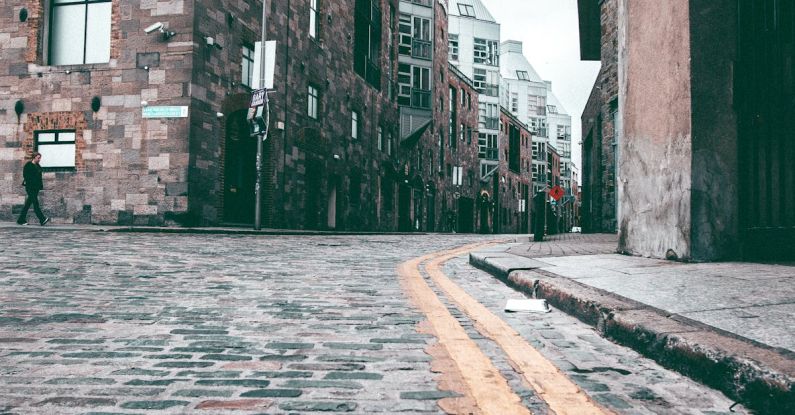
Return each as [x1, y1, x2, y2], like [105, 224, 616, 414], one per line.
[223, 111, 257, 224]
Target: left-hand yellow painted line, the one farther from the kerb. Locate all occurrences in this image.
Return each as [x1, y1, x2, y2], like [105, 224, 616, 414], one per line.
[398, 244, 531, 415]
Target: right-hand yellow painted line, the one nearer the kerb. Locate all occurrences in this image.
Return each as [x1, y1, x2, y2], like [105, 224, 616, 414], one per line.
[425, 248, 611, 415]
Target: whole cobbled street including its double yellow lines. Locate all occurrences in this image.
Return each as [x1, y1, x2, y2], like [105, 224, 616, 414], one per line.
[0, 227, 742, 414]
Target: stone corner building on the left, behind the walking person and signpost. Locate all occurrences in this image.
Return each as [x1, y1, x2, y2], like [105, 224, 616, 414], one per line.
[0, 0, 399, 230]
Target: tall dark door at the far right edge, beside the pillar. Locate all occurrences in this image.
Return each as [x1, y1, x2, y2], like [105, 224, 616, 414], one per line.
[736, 0, 795, 260]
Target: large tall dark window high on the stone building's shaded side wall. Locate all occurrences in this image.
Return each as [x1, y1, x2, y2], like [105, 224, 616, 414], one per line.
[353, 0, 381, 89]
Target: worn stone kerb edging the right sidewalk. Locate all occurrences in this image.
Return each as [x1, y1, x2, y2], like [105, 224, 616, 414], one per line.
[469, 252, 795, 414]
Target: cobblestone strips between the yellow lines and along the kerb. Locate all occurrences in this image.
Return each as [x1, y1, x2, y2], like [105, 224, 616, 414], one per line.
[444, 256, 745, 415]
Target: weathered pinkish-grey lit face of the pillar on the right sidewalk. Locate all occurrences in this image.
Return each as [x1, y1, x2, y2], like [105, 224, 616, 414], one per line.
[619, 0, 693, 258]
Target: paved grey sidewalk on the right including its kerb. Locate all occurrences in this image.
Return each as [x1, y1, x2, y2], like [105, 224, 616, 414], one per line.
[470, 234, 795, 414]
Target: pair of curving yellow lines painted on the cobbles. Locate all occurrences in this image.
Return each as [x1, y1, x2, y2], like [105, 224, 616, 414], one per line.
[398, 244, 610, 415]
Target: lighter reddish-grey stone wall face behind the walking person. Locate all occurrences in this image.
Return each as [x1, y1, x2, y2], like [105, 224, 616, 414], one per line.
[0, 0, 192, 225]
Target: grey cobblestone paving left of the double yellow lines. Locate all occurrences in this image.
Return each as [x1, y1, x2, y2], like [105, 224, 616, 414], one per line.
[0, 228, 493, 414]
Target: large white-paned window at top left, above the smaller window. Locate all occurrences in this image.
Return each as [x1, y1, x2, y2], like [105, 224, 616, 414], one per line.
[48, 0, 112, 65]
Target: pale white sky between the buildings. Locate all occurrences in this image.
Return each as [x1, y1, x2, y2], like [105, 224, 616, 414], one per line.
[481, 0, 599, 171]
